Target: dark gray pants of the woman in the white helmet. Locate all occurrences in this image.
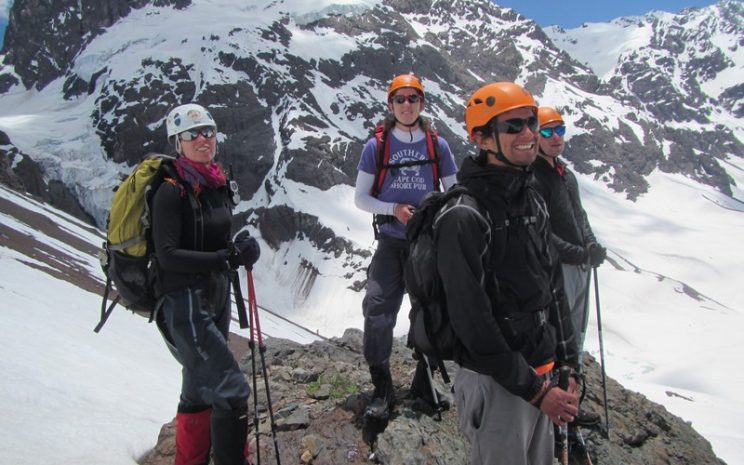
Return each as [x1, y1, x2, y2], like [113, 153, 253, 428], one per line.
[158, 272, 251, 414]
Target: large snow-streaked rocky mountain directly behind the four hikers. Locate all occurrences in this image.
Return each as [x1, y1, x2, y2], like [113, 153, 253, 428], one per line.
[0, 0, 742, 326]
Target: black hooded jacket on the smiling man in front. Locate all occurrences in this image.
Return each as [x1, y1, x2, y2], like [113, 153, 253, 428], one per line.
[436, 158, 578, 401]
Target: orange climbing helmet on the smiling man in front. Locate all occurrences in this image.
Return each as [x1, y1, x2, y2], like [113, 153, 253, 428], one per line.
[465, 82, 537, 139]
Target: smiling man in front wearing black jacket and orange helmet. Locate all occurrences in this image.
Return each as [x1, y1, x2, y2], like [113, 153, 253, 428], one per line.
[436, 82, 578, 465]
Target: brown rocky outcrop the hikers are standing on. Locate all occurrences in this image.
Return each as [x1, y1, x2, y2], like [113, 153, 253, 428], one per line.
[139, 330, 724, 465]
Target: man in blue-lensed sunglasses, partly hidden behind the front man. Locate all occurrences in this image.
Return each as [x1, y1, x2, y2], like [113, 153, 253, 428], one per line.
[533, 107, 607, 426]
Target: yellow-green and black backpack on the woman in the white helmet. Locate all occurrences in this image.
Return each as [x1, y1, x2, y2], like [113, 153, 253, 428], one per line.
[94, 153, 186, 332]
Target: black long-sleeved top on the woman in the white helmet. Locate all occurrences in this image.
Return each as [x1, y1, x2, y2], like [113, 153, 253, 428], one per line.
[152, 176, 232, 297]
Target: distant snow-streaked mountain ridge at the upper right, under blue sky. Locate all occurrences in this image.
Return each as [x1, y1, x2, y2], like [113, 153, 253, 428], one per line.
[546, 0, 744, 194]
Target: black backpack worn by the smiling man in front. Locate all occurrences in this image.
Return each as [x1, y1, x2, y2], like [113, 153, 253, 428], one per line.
[404, 185, 488, 383]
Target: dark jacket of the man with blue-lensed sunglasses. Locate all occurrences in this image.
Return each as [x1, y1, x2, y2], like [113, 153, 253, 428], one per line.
[532, 157, 596, 265]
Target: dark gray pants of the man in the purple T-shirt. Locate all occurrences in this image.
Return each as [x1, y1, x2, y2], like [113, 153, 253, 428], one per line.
[362, 235, 408, 366]
